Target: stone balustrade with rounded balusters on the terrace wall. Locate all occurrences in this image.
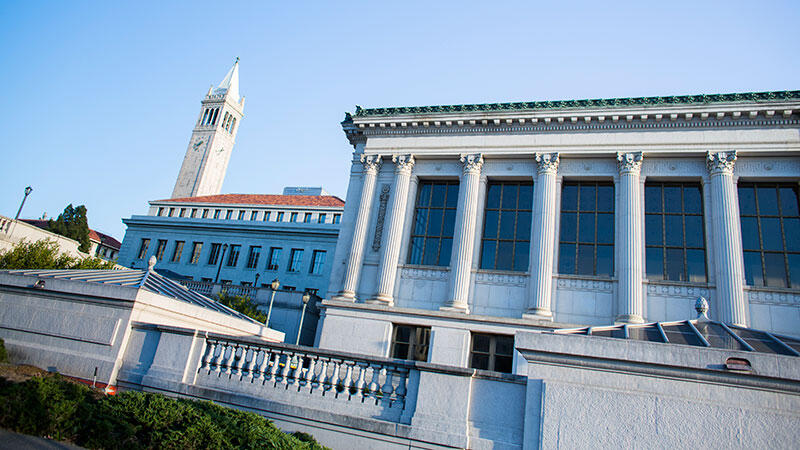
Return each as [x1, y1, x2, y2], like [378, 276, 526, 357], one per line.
[198, 335, 410, 411]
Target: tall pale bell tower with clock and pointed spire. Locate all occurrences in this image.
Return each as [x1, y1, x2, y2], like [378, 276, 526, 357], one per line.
[172, 58, 244, 198]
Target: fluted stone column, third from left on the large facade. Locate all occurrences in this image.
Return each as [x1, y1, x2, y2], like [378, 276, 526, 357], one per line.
[440, 153, 483, 313]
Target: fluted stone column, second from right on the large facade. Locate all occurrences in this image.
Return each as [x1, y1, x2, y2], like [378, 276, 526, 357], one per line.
[616, 152, 644, 323]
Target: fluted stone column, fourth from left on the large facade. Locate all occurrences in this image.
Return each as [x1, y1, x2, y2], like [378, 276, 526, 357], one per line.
[523, 153, 559, 320]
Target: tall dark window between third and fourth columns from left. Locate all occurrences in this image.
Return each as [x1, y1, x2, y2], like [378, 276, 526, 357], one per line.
[481, 182, 533, 272]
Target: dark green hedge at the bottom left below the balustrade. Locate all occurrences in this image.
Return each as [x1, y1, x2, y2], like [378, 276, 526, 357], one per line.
[0, 375, 323, 449]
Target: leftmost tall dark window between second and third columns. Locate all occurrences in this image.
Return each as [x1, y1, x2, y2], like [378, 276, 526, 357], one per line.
[410, 181, 458, 266]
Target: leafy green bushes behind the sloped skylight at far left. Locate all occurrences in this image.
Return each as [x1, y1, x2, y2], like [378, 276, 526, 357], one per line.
[0, 239, 115, 270]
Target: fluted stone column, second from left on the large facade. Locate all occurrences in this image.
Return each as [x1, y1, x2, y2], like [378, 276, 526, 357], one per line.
[368, 155, 414, 305]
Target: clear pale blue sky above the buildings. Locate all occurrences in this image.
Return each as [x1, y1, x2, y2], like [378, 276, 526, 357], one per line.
[0, 0, 800, 240]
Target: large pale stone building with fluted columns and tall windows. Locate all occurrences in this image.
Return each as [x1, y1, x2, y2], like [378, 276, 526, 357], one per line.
[318, 91, 800, 373]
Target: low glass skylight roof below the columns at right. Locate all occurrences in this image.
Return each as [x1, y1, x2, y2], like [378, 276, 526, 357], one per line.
[549, 320, 800, 356]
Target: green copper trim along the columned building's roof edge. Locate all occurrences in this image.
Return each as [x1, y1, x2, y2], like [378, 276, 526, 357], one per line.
[352, 91, 800, 117]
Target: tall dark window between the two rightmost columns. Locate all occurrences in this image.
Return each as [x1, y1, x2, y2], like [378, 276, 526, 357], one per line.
[644, 182, 707, 283]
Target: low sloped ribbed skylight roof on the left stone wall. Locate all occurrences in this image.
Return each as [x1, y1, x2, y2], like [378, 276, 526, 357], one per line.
[2, 269, 264, 325]
